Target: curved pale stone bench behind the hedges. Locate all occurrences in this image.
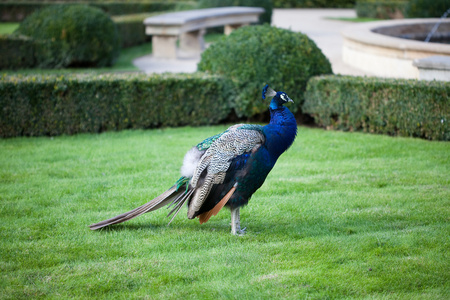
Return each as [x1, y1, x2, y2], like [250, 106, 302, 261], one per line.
[144, 6, 264, 58]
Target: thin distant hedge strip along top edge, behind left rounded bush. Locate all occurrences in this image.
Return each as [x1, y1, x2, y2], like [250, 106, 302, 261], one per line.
[0, 1, 185, 22]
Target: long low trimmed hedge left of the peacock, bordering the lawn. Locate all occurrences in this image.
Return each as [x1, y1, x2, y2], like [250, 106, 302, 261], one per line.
[0, 73, 230, 137]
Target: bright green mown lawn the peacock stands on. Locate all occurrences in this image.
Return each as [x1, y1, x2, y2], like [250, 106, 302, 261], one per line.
[0, 126, 450, 299]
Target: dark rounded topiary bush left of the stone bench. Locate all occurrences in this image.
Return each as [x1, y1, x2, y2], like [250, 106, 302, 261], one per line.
[15, 5, 119, 68]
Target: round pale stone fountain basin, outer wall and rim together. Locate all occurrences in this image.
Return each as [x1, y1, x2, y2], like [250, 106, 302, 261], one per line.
[342, 19, 450, 79]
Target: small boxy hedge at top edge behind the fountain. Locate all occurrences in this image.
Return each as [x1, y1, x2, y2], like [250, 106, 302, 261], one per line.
[355, 0, 408, 19]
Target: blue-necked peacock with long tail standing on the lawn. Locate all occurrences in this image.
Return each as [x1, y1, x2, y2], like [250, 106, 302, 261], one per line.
[90, 85, 297, 235]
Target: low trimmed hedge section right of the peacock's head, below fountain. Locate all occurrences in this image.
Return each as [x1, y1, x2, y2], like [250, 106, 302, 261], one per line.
[303, 76, 450, 141]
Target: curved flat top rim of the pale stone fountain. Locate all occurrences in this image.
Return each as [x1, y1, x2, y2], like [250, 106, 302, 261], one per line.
[341, 18, 450, 55]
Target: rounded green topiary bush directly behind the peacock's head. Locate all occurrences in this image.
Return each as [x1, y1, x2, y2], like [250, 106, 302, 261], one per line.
[198, 25, 332, 117]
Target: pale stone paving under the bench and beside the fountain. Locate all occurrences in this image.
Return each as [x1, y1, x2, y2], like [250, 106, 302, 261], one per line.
[133, 9, 372, 76]
